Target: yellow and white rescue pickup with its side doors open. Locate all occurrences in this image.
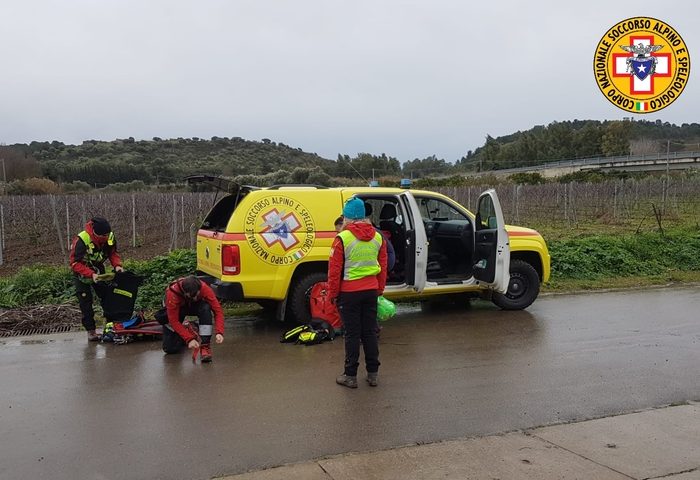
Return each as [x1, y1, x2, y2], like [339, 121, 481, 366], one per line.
[187, 175, 550, 323]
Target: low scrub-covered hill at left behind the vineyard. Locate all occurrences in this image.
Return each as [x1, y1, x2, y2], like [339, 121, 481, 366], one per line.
[10, 137, 335, 187]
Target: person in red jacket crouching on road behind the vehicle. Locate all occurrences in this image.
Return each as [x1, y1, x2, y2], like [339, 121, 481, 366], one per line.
[163, 275, 224, 363]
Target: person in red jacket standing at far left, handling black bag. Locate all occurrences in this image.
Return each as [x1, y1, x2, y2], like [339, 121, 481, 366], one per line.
[70, 217, 124, 342]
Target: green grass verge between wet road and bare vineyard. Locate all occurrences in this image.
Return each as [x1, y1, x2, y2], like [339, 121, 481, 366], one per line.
[0, 225, 700, 314]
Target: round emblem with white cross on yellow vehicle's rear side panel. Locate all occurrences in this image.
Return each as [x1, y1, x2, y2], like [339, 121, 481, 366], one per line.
[244, 195, 315, 265]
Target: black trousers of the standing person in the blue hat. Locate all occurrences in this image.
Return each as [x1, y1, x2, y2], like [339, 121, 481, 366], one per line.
[338, 290, 380, 377]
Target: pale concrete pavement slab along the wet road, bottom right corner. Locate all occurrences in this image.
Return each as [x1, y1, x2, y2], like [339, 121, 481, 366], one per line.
[222, 403, 700, 480]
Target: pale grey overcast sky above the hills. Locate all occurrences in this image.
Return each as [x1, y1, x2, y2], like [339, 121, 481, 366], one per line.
[0, 0, 700, 162]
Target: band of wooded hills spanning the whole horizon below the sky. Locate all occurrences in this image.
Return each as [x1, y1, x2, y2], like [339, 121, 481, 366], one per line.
[0, 119, 700, 193]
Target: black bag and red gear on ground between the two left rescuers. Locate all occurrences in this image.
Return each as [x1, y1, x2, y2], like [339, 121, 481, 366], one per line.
[98, 272, 163, 345]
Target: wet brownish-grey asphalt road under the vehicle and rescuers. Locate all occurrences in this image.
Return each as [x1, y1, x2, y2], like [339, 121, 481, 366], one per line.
[0, 287, 700, 480]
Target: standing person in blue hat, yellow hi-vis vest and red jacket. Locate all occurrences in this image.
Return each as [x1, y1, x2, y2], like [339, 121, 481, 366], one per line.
[328, 197, 387, 388]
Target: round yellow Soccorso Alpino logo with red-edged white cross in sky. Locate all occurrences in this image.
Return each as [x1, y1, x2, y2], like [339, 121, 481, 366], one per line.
[593, 17, 690, 113]
